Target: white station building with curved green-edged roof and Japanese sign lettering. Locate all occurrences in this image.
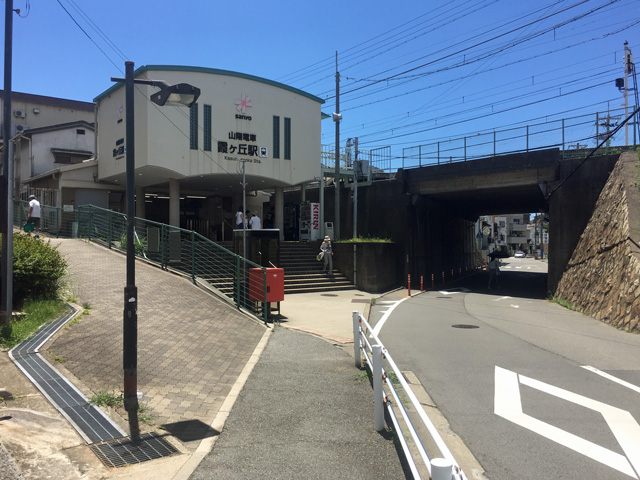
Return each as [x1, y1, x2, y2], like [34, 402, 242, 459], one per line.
[95, 65, 323, 240]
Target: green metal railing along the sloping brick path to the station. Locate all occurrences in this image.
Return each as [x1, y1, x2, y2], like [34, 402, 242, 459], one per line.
[76, 205, 268, 323]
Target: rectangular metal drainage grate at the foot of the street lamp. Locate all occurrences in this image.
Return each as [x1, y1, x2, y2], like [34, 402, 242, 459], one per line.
[91, 433, 178, 467]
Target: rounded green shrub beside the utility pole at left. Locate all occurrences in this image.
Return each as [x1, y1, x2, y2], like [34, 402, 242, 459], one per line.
[13, 233, 67, 305]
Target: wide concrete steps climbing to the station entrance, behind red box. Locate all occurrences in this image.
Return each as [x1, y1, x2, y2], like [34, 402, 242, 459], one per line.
[278, 242, 355, 294]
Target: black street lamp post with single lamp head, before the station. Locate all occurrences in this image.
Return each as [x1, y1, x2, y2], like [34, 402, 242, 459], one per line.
[111, 62, 200, 437]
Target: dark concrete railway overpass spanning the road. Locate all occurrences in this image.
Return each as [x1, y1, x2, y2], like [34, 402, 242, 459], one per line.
[302, 149, 619, 292]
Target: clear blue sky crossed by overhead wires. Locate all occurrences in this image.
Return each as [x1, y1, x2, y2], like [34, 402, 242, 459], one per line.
[2, 0, 640, 163]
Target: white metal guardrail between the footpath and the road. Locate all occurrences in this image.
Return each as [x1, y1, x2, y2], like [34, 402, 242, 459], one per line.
[353, 311, 467, 480]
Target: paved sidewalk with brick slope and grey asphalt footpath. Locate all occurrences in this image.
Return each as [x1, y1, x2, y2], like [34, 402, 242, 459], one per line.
[0, 239, 404, 480]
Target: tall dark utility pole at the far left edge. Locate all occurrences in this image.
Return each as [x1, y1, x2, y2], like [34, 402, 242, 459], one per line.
[0, 0, 13, 325]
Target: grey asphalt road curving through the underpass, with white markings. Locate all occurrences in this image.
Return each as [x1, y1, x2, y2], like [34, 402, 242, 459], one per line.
[370, 258, 640, 480]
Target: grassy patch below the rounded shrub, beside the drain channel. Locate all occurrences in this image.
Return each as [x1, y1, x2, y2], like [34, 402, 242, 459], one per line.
[0, 300, 67, 348]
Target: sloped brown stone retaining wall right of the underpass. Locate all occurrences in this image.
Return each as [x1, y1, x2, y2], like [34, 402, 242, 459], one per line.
[555, 152, 640, 332]
